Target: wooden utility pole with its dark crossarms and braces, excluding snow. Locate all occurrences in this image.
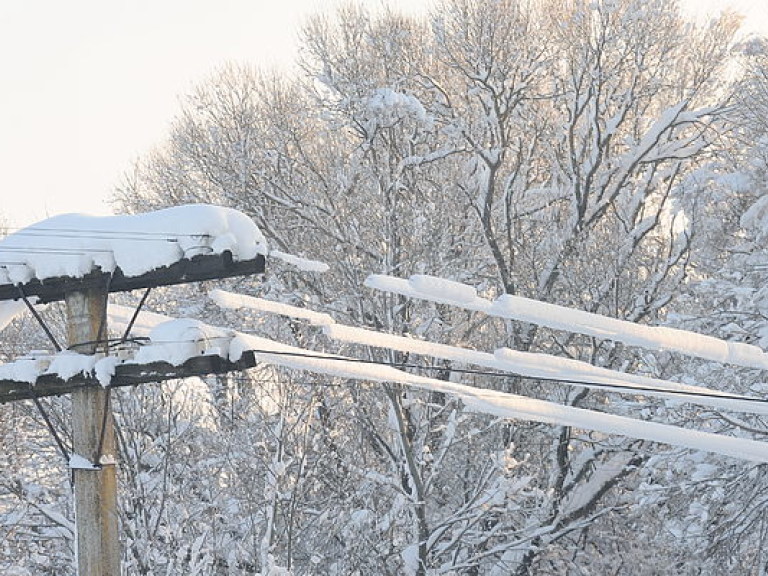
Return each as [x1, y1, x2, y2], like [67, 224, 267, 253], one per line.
[0, 251, 265, 576]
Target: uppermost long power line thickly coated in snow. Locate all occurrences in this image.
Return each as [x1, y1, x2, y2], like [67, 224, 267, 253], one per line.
[365, 274, 768, 370]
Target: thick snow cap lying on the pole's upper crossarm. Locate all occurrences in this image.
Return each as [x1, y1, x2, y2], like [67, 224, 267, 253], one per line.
[0, 204, 268, 285]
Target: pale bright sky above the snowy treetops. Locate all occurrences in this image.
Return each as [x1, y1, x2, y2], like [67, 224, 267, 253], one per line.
[0, 0, 768, 226]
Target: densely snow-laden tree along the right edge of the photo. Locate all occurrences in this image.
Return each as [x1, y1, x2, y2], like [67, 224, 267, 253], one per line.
[652, 38, 768, 574]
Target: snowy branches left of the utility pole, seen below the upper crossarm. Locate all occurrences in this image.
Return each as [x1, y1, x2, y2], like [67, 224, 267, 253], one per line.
[0, 246, 74, 576]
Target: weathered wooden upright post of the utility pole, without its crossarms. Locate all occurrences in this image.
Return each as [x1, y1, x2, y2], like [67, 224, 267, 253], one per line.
[65, 288, 120, 576]
